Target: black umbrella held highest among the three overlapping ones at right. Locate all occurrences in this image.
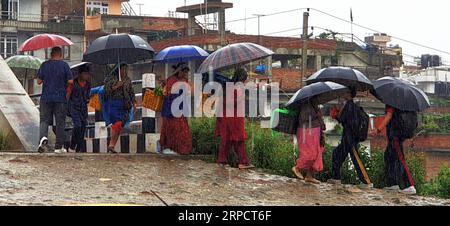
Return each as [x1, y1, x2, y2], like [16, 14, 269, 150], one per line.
[306, 67, 373, 91]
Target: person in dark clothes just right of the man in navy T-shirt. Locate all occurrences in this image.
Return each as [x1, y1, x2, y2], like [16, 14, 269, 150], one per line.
[67, 66, 91, 153]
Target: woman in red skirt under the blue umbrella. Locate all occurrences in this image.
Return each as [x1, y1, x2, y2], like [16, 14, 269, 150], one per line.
[160, 63, 192, 155]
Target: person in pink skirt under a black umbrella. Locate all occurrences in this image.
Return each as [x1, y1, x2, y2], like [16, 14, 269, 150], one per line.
[292, 100, 325, 184]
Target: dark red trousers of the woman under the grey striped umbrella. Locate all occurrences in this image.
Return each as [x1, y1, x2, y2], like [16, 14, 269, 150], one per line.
[218, 139, 250, 165]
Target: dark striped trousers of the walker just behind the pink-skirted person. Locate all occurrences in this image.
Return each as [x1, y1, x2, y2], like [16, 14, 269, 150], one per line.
[332, 132, 371, 184]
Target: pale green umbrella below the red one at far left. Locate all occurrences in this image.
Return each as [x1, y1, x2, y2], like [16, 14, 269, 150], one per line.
[6, 55, 44, 79]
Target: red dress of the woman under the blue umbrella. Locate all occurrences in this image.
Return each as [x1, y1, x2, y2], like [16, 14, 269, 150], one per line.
[159, 76, 192, 155]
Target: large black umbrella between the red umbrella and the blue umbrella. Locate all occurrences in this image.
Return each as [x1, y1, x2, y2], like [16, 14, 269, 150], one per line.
[83, 34, 155, 64]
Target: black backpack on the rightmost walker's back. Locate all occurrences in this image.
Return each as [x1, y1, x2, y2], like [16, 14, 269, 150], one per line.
[393, 110, 419, 139]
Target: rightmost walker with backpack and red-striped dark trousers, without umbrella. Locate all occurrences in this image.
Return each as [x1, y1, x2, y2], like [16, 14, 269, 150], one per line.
[371, 105, 417, 195]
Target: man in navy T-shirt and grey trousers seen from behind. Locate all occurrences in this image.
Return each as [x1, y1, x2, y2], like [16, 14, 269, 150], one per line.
[38, 47, 73, 153]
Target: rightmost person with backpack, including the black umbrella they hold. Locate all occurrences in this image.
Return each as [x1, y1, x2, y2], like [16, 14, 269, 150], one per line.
[371, 77, 430, 195]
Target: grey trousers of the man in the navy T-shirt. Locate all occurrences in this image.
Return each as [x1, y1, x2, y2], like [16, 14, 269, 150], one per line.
[39, 102, 67, 149]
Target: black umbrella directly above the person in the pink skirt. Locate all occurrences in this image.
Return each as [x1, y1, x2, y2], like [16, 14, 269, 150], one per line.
[286, 82, 350, 108]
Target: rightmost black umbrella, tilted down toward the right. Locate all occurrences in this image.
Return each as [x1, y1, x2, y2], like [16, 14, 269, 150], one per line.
[372, 77, 430, 112]
